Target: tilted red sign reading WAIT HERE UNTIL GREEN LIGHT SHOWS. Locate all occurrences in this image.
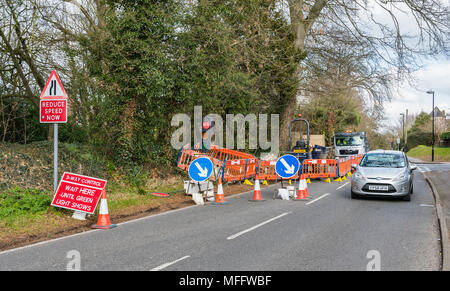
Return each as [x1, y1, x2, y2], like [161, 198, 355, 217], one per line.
[51, 172, 106, 214]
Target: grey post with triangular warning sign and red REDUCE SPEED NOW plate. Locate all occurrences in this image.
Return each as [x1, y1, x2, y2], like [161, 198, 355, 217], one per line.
[39, 70, 67, 193]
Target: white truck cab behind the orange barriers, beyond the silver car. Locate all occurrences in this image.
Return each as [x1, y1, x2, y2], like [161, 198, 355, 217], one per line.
[333, 131, 369, 157]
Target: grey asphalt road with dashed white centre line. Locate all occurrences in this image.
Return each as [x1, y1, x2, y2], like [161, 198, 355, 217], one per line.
[0, 171, 440, 271]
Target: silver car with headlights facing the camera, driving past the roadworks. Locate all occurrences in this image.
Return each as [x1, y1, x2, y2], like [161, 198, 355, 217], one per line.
[351, 150, 417, 201]
